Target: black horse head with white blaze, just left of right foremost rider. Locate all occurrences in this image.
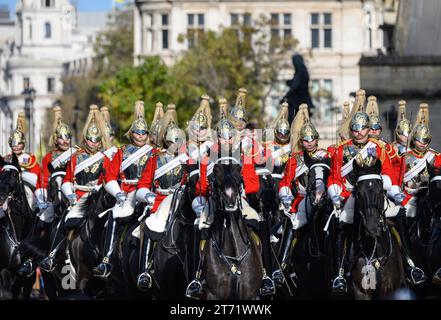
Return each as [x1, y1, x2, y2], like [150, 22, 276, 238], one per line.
[303, 152, 331, 206]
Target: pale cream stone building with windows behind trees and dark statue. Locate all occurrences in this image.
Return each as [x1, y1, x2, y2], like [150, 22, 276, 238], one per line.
[134, 0, 398, 136]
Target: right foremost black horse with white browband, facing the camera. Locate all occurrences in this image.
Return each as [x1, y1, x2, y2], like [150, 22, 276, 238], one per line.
[349, 158, 405, 300]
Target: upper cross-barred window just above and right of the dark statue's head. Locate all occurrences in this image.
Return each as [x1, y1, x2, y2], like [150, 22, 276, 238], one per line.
[311, 13, 332, 49]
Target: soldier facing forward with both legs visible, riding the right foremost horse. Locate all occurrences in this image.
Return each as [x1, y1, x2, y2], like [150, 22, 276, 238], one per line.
[328, 91, 425, 294]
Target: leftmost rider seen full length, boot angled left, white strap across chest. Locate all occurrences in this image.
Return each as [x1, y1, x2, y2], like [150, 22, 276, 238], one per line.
[40, 105, 110, 272]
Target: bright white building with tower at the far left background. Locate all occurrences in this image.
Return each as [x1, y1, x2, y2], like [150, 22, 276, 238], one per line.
[0, 0, 105, 154]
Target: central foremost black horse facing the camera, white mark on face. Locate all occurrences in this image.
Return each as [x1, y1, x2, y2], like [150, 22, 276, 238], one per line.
[202, 164, 263, 300]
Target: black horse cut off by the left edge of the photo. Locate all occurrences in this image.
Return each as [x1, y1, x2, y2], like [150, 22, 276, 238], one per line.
[0, 155, 35, 299]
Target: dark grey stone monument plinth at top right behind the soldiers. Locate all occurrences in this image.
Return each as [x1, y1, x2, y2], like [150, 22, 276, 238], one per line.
[360, 0, 441, 150]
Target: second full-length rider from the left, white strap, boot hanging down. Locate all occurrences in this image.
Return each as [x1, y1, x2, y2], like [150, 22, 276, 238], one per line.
[93, 101, 154, 278]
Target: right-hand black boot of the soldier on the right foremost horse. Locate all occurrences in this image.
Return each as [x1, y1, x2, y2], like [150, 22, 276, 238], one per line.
[392, 210, 427, 285]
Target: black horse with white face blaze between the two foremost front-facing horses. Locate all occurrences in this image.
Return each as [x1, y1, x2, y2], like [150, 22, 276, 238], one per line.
[278, 153, 330, 299]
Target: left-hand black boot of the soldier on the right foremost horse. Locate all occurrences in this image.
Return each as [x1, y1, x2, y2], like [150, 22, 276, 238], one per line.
[331, 224, 350, 295]
